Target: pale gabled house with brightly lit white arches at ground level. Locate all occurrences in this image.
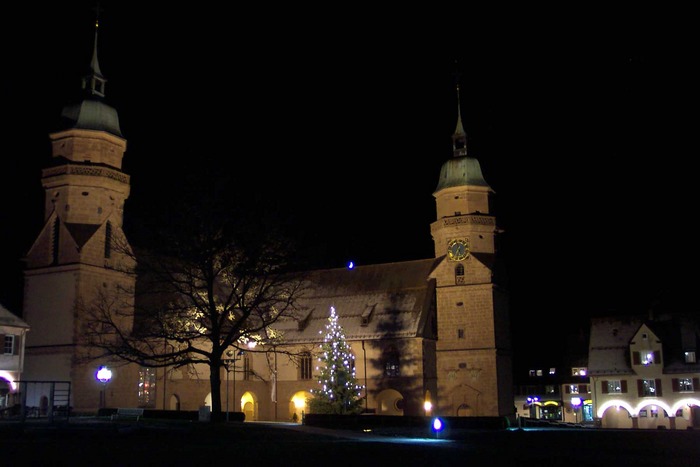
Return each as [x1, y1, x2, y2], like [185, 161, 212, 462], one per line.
[588, 314, 700, 430]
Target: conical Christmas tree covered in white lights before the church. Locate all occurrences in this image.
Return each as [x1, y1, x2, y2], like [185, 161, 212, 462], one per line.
[309, 307, 363, 414]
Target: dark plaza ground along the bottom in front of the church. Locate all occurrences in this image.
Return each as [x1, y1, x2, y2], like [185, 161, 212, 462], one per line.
[0, 419, 700, 467]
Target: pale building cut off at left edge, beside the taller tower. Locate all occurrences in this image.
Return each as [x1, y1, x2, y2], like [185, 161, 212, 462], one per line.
[0, 305, 29, 414]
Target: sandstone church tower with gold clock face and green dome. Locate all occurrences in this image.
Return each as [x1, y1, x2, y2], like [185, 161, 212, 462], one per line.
[430, 85, 514, 417]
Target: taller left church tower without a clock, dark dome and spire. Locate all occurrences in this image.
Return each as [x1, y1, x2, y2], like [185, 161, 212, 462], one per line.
[23, 18, 134, 412]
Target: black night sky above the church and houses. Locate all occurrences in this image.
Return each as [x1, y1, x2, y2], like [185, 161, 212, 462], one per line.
[0, 2, 698, 358]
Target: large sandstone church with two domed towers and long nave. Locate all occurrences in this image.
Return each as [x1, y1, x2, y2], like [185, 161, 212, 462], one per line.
[24, 20, 514, 420]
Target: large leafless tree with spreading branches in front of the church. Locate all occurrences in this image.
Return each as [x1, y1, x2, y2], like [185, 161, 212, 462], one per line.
[77, 194, 304, 421]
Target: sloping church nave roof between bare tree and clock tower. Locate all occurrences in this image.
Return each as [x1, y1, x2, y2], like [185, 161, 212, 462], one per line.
[273, 258, 440, 343]
